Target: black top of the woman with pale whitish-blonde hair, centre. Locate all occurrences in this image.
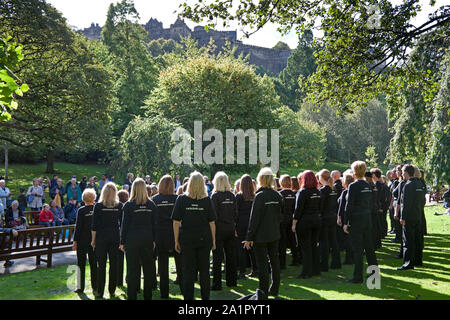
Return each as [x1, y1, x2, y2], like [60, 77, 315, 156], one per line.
[211, 191, 237, 240]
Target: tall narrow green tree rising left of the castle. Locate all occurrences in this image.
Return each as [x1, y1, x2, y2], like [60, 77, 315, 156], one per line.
[102, 0, 158, 138]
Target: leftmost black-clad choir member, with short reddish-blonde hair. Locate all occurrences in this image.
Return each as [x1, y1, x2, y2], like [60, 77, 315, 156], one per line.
[73, 189, 97, 295]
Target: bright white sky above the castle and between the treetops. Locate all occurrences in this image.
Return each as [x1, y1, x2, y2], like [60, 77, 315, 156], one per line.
[47, 0, 448, 49]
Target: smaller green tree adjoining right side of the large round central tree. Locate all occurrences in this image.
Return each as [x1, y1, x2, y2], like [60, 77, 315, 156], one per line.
[274, 106, 326, 168]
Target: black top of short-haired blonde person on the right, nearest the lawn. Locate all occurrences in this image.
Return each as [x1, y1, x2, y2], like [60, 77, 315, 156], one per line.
[343, 180, 373, 224]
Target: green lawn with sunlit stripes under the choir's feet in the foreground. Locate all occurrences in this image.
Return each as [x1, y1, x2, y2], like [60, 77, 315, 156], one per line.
[0, 206, 450, 300]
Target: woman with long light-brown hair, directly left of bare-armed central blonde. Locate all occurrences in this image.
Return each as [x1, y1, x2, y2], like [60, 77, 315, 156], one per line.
[152, 175, 183, 299]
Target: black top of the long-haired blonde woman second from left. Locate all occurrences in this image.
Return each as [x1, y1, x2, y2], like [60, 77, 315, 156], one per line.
[92, 202, 123, 244]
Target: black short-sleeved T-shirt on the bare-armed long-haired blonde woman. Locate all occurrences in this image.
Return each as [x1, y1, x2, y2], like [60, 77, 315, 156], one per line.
[172, 194, 217, 248]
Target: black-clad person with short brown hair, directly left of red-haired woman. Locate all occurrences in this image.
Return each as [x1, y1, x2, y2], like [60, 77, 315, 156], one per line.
[280, 174, 300, 270]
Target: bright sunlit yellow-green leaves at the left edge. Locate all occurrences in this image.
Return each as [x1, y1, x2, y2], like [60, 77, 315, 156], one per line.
[0, 37, 28, 121]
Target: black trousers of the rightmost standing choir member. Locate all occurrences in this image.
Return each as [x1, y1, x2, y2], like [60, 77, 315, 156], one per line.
[403, 221, 423, 267]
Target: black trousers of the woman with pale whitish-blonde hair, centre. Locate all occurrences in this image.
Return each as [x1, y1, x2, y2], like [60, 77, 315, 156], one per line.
[213, 233, 237, 288]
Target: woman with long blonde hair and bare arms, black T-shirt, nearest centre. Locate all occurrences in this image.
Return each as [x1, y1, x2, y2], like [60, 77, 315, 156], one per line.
[172, 171, 217, 300]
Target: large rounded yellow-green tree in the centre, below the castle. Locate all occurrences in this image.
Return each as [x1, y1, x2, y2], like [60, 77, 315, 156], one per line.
[146, 43, 280, 173]
